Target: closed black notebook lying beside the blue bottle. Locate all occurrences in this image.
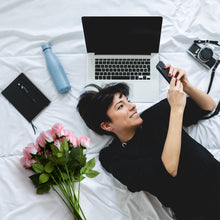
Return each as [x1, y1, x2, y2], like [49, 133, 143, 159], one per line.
[2, 73, 50, 122]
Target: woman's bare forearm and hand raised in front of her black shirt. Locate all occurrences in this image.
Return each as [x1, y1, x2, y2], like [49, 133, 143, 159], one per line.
[161, 78, 186, 177]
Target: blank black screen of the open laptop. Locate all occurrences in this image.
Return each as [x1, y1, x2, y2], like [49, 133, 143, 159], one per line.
[82, 17, 162, 54]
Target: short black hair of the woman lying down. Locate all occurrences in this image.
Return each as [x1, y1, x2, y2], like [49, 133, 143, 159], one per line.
[77, 83, 129, 135]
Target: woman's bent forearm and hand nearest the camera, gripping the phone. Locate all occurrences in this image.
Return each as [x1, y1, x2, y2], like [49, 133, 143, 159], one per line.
[166, 64, 216, 111]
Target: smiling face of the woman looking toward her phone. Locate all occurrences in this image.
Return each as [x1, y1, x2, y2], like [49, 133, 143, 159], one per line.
[107, 93, 143, 135]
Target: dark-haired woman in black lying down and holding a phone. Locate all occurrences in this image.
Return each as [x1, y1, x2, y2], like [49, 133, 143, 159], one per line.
[77, 65, 220, 220]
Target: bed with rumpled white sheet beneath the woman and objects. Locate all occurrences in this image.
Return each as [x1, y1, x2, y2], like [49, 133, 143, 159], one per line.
[0, 0, 220, 220]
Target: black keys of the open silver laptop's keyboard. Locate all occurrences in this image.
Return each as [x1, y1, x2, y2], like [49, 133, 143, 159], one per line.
[95, 59, 150, 80]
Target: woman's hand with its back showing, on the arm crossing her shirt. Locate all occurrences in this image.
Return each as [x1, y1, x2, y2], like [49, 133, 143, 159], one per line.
[167, 77, 186, 112]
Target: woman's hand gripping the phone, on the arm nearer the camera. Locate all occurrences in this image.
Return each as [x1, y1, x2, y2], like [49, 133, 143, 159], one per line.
[164, 64, 190, 91]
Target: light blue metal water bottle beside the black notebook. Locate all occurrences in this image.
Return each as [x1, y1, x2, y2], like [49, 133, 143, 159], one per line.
[41, 43, 71, 93]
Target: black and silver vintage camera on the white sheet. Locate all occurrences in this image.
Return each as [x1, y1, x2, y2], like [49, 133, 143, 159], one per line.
[187, 40, 220, 69]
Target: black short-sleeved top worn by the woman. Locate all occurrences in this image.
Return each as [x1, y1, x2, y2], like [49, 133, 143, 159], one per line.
[99, 98, 220, 219]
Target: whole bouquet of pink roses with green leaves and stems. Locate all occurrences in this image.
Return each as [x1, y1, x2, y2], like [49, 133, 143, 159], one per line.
[21, 123, 99, 220]
